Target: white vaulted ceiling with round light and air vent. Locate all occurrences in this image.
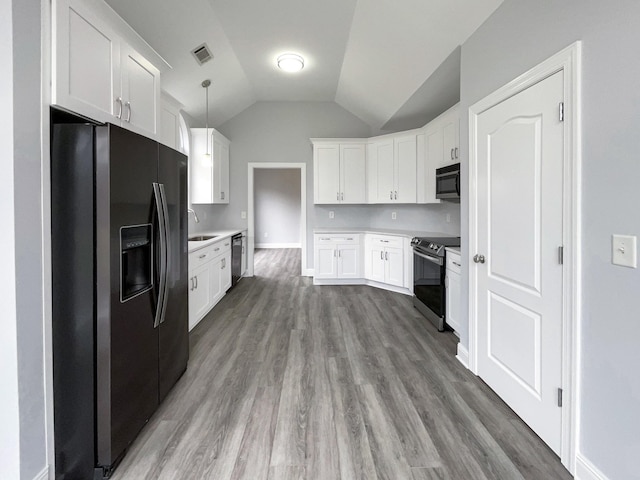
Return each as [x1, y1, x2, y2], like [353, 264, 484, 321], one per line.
[106, 0, 503, 130]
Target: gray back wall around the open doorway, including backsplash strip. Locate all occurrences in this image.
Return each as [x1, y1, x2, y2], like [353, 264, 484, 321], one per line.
[190, 102, 460, 268]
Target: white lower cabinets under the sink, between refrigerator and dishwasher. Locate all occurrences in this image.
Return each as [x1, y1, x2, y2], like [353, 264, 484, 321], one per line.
[189, 238, 231, 330]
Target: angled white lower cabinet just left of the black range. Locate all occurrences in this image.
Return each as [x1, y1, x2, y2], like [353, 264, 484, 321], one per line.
[365, 235, 405, 287]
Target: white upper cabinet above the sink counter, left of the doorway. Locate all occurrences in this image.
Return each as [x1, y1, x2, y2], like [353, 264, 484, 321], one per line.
[189, 128, 230, 204]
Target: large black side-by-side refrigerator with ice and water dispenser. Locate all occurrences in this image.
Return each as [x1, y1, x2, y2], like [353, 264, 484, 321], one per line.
[51, 114, 189, 479]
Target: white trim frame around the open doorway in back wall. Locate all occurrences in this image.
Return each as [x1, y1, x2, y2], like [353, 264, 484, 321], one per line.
[247, 162, 307, 277]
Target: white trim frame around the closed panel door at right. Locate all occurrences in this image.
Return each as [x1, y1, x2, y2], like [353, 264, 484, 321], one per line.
[468, 42, 582, 473]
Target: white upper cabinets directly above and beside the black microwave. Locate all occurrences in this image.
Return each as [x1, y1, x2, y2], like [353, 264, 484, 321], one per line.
[418, 105, 460, 203]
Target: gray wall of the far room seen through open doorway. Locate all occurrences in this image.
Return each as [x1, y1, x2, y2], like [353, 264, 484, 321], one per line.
[253, 168, 301, 244]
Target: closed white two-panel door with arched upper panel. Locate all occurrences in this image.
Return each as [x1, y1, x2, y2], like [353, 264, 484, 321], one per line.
[472, 72, 564, 453]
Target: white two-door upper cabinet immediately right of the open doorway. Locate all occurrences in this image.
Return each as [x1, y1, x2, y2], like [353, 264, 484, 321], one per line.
[312, 139, 367, 204]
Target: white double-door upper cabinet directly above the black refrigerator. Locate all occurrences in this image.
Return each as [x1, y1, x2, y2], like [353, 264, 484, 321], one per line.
[52, 0, 160, 138]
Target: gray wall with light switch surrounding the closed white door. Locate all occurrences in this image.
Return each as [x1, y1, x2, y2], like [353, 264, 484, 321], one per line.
[460, 0, 640, 479]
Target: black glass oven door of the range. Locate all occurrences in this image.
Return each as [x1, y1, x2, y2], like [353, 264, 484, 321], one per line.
[413, 248, 445, 331]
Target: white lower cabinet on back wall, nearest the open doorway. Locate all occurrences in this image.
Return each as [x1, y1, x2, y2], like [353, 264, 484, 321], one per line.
[314, 234, 362, 279]
